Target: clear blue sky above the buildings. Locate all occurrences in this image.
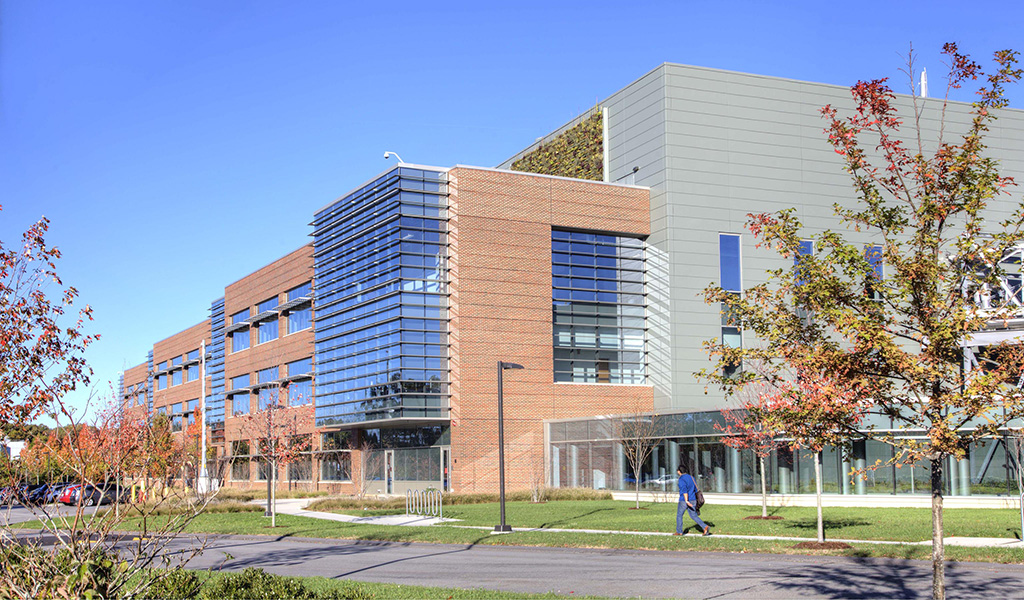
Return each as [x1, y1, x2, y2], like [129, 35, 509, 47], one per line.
[0, 0, 1024, 417]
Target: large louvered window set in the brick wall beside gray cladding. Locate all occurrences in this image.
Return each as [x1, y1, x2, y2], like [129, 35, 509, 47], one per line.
[551, 229, 647, 384]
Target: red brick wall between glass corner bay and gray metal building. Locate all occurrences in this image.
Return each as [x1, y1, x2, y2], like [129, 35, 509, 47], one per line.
[450, 167, 653, 492]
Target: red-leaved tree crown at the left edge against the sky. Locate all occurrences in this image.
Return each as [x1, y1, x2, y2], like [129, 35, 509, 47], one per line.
[0, 207, 99, 421]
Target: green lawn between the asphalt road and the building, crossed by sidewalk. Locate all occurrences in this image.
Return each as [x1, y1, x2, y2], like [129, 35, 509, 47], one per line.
[16, 501, 1024, 563]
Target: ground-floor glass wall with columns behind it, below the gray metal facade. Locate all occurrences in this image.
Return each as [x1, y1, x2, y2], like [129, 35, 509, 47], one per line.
[548, 413, 1024, 496]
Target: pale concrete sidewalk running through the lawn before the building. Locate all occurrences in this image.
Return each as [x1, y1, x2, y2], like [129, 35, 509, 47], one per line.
[262, 498, 1024, 549]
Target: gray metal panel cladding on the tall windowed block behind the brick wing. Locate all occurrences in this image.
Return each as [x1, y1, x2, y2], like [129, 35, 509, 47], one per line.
[601, 65, 1024, 411]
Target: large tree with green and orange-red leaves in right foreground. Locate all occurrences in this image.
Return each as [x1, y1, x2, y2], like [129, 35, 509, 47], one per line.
[702, 44, 1024, 598]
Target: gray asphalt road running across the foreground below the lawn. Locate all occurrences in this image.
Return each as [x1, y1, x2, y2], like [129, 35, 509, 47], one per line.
[142, 537, 1024, 600]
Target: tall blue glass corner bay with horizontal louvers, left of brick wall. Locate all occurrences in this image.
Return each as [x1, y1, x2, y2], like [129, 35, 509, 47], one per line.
[313, 167, 449, 427]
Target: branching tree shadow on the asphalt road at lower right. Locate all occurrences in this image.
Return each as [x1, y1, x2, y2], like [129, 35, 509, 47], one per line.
[769, 557, 1024, 599]
